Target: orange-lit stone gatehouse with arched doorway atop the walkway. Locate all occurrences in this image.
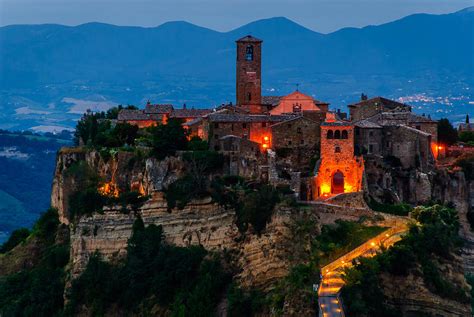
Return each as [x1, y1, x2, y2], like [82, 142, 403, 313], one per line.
[312, 114, 364, 199]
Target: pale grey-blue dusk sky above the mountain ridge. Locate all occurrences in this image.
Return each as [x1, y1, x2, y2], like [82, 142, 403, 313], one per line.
[0, 0, 474, 33]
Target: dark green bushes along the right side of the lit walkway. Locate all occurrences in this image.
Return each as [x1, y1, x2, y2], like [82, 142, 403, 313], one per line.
[342, 205, 468, 316]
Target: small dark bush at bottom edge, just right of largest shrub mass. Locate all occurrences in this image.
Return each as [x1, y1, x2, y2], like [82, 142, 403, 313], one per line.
[227, 283, 265, 317]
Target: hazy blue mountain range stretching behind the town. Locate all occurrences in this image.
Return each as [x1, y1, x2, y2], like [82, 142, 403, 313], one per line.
[0, 8, 474, 128]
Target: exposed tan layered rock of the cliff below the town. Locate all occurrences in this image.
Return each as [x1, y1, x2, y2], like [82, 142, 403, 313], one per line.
[51, 149, 474, 315]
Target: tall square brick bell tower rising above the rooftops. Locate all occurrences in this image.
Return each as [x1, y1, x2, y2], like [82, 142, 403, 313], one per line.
[236, 35, 262, 113]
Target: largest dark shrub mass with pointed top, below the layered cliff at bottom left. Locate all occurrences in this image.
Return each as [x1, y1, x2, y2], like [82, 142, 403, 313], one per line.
[67, 218, 229, 316]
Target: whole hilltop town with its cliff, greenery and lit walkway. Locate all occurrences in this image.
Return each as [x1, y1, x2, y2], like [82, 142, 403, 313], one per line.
[0, 35, 474, 316]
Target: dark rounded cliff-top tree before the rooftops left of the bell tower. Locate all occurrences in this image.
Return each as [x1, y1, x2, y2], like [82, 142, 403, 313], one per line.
[148, 119, 188, 159]
